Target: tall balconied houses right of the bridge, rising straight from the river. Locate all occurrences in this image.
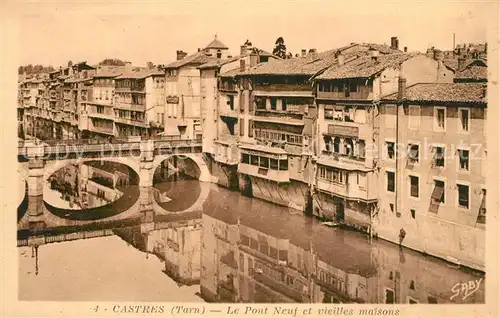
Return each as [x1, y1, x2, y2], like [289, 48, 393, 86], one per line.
[199, 38, 487, 269]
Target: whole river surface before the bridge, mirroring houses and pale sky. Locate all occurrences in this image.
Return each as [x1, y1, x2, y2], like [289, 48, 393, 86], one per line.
[18, 176, 484, 303]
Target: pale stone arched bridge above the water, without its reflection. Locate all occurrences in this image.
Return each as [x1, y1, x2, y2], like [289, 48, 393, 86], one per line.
[18, 138, 212, 196]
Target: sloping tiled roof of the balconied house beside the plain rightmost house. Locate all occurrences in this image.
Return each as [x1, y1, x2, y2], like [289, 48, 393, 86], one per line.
[317, 53, 415, 80]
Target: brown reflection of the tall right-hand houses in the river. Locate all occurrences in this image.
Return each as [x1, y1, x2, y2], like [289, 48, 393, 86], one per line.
[201, 190, 484, 303]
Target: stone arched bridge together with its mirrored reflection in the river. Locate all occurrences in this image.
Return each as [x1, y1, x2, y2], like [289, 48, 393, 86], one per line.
[18, 139, 216, 246]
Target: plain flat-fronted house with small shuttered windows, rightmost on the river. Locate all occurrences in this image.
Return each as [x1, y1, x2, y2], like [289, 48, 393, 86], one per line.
[373, 82, 487, 269]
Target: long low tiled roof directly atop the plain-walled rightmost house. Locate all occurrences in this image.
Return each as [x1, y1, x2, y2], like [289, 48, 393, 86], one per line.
[382, 83, 486, 103]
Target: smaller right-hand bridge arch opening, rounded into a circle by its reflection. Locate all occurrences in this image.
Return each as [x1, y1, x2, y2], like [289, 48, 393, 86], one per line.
[153, 156, 201, 212]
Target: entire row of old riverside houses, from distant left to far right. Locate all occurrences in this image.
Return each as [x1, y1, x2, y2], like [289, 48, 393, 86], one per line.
[19, 37, 487, 269]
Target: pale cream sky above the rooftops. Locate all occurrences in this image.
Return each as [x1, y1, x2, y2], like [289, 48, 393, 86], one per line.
[4, 0, 498, 66]
